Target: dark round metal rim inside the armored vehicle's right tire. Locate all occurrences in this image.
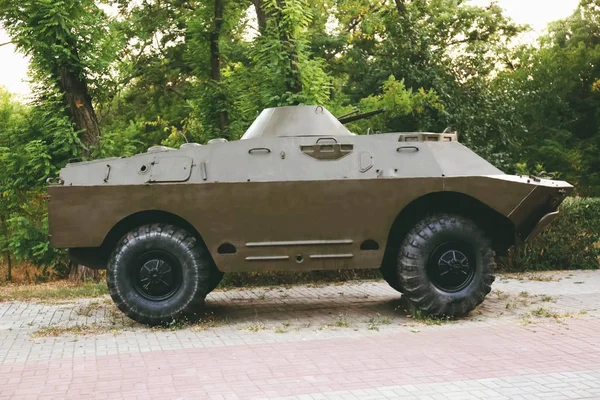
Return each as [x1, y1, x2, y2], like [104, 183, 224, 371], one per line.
[427, 242, 476, 293]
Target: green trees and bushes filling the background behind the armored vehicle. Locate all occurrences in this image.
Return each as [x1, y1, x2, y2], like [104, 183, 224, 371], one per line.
[0, 0, 600, 285]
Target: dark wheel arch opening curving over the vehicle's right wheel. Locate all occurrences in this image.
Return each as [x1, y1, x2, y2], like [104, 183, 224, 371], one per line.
[382, 192, 515, 267]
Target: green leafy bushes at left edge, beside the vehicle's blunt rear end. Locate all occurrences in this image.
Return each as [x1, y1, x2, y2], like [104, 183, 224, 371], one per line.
[0, 89, 80, 271]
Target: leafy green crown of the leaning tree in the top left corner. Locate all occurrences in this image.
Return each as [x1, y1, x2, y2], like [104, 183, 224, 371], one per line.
[0, 0, 123, 99]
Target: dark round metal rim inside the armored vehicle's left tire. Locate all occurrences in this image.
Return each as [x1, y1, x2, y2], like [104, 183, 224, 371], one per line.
[131, 251, 183, 301]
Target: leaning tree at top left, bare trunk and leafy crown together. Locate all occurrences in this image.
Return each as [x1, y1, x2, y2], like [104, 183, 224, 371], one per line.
[0, 0, 117, 155]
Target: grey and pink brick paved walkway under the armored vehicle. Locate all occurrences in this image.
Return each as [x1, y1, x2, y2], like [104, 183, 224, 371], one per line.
[0, 271, 600, 400]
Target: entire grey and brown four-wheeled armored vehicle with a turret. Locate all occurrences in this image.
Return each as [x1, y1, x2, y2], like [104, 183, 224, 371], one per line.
[48, 106, 573, 324]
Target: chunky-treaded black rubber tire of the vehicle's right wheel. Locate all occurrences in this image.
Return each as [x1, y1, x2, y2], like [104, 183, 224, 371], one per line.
[398, 214, 496, 317]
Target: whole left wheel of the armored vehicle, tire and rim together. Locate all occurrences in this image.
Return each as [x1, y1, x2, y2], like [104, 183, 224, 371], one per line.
[106, 224, 212, 325]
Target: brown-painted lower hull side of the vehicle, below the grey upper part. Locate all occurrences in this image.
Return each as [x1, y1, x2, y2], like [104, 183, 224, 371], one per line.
[49, 175, 557, 272]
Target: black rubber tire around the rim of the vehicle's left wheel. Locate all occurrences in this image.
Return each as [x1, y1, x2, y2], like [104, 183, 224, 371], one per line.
[106, 224, 212, 325]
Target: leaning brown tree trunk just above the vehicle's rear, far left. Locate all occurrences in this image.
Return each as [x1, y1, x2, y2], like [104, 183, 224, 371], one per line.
[58, 65, 100, 156]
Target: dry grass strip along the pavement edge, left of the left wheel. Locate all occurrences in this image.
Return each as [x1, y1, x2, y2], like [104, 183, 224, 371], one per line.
[0, 281, 108, 303]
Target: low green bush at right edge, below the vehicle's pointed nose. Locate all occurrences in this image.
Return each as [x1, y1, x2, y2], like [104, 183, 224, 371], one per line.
[501, 198, 600, 271]
